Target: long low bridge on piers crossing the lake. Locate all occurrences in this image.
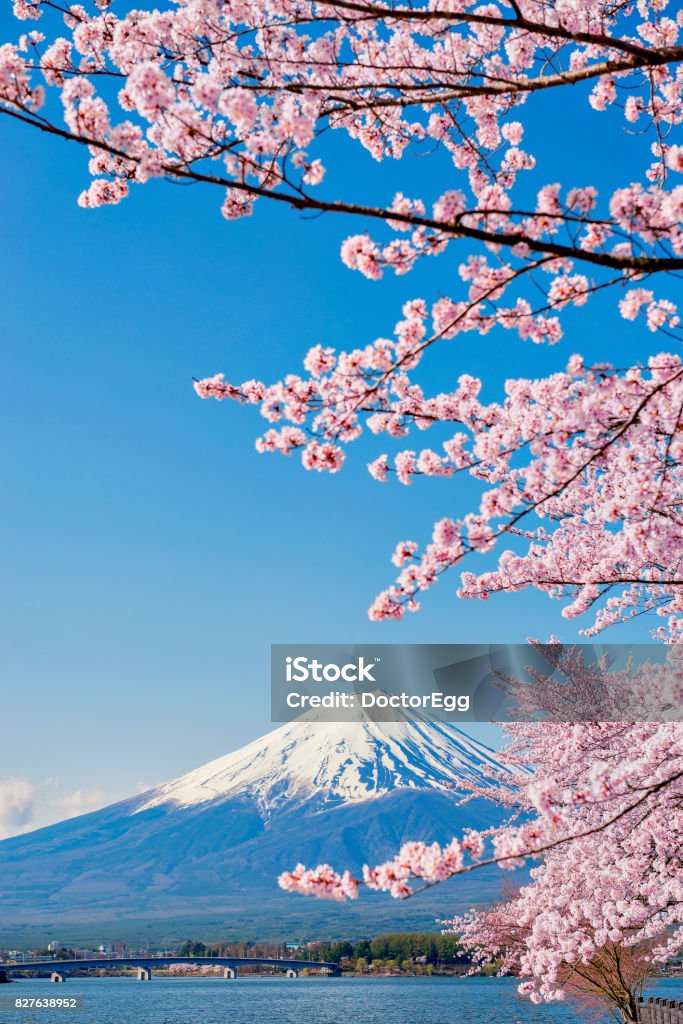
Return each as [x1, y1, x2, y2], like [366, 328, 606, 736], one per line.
[0, 956, 339, 982]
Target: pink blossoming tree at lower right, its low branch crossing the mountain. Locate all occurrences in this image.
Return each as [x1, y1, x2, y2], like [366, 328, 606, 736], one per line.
[280, 645, 683, 1007]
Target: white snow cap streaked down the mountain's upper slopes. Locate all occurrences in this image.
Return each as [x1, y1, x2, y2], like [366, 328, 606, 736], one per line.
[136, 714, 503, 818]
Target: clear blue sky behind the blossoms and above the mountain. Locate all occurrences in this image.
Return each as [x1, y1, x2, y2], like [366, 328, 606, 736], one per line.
[0, 19, 659, 835]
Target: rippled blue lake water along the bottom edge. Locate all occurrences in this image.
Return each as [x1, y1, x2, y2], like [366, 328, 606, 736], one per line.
[0, 978, 683, 1024]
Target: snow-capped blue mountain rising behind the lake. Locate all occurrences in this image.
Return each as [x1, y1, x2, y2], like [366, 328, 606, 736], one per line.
[0, 715, 505, 937]
